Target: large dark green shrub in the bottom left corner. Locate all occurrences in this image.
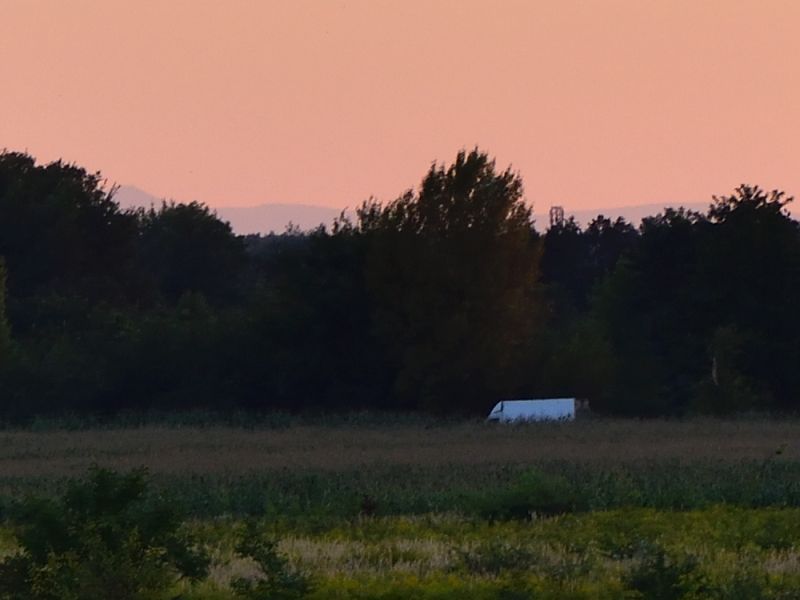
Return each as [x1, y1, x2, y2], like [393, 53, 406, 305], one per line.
[0, 468, 208, 600]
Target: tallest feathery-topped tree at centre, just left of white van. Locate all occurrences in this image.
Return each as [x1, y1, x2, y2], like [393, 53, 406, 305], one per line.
[358, 149, 540, 412]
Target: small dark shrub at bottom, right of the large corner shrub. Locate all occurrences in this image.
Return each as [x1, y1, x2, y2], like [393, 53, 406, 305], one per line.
[231, 521, 312, 600]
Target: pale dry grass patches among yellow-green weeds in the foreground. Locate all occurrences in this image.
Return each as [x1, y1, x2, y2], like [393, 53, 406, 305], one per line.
[202, 511, 800, 584]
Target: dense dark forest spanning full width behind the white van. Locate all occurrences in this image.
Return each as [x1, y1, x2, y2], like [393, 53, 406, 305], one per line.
[0, 150, 800, 421]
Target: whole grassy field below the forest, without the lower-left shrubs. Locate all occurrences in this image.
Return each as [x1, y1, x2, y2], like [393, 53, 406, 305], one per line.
[0, 419, 800, 599]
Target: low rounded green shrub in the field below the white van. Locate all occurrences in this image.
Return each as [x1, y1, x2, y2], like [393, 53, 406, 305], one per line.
[476, 469, 578, 520]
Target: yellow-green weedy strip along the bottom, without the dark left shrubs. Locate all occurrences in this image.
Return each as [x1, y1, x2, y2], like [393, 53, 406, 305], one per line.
[0, 506, 800, 600]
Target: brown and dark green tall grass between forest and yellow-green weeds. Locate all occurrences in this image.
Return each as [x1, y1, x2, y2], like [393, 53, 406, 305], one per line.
[0, 415, 800, 522]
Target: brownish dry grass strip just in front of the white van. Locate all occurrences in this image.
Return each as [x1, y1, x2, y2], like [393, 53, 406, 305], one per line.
[0, 419, 800, 477]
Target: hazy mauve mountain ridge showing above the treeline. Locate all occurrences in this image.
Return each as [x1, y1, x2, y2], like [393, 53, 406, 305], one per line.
[114, 185, 709, 235]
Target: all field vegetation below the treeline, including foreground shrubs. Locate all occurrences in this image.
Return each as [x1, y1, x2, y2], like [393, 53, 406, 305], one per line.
[0, 421, 800, 600]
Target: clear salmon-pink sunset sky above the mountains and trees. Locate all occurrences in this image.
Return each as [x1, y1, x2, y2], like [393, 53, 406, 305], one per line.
[0, 0, 800, 213]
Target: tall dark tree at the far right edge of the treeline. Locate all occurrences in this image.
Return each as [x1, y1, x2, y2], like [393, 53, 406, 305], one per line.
[697, 185, 800, 410]
